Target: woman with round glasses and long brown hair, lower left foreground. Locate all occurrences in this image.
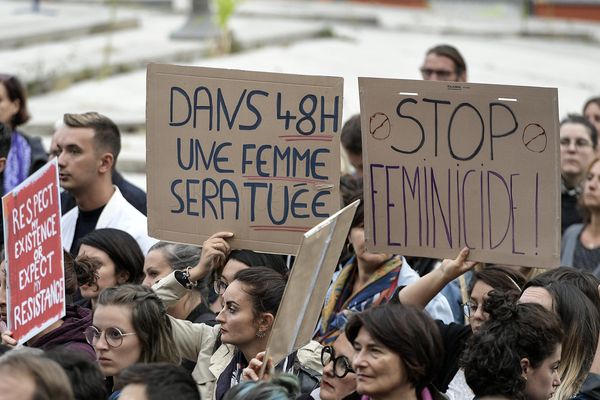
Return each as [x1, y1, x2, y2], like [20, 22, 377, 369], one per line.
[85, 284, 180, 391]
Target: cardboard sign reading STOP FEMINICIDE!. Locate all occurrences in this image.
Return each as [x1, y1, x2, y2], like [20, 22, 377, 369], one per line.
[359, 78, 560, 268]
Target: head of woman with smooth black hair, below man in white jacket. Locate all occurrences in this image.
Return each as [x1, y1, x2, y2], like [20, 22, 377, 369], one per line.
[77, 228, 144, 308]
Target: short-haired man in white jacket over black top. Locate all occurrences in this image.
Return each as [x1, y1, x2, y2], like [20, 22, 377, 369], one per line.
[55, 112, 156, 255]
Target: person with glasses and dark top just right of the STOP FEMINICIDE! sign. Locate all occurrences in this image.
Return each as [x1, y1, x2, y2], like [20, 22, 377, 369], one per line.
[559, 114, 598, 233]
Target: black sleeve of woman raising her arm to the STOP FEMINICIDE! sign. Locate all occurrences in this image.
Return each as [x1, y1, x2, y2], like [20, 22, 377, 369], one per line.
[433, 320, 472, 393]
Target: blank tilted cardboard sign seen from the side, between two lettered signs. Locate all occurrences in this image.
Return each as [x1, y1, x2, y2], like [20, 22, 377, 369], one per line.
[265, 200, 359, 365]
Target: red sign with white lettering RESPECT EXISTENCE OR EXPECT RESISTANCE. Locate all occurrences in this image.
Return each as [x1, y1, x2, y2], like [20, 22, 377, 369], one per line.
[2, 159, 65, 343]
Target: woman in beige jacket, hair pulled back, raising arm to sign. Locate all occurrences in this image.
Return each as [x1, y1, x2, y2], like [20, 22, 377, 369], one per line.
[153, 264, 321, 400]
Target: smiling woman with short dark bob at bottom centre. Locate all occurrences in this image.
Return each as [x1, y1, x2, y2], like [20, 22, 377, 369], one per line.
[346, 304, 444, 400]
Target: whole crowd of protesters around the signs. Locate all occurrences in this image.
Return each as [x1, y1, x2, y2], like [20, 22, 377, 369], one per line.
[0, 45, 600, 400]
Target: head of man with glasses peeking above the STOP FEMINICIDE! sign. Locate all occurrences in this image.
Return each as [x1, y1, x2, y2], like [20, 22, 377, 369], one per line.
[421, 44, 467, 82]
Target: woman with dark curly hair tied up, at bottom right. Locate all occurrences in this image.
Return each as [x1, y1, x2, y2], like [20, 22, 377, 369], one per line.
[461, 293, 563, 400]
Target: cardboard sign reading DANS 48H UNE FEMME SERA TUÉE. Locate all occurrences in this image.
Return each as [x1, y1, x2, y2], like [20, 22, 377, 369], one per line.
[146, 64, 343, 254]
